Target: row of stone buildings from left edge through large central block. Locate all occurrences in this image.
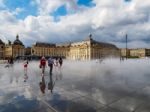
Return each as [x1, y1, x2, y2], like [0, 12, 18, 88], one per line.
[0, 35, 120, 60]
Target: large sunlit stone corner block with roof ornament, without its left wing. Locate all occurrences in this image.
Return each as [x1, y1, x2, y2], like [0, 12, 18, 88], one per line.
[69, 35, 120, 60]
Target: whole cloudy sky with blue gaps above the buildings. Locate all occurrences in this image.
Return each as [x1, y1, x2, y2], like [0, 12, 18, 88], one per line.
[0, 0, 150, 48]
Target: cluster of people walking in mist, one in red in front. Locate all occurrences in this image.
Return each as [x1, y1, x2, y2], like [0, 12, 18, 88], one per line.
[39, 56, 63, 74]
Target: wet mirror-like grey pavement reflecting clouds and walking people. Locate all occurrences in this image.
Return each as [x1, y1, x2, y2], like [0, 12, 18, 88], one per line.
[0, 59, 150, 112]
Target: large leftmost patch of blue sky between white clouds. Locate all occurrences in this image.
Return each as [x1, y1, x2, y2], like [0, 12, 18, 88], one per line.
[4, 0, 37, 19]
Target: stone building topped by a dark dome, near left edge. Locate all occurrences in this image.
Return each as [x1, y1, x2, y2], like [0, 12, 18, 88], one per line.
[5, 35, 25, 58]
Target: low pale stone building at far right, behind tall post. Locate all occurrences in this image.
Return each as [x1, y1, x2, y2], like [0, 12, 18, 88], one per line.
[121, 48, 150, 58]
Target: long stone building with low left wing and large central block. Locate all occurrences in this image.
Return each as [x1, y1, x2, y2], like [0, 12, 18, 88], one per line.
[31, 35, 119, 60]
